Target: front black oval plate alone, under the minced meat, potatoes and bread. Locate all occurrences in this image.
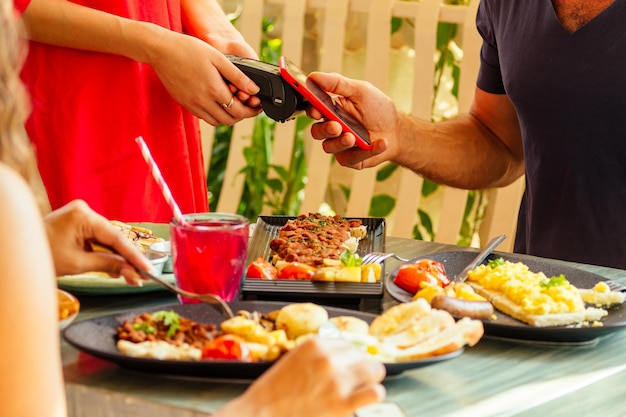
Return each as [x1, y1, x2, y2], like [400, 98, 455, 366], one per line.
[63, 301, 463, 379]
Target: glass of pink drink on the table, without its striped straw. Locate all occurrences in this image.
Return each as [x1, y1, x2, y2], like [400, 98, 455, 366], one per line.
[170, 213, 249, 304]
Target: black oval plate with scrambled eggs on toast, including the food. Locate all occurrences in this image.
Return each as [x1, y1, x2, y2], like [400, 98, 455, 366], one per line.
[385, 251, 626, 344]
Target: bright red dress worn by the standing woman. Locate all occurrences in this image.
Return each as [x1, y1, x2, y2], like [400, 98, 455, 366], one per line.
[22, 0, 208, 222]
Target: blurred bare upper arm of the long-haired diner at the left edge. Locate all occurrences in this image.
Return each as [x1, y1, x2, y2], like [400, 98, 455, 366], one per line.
[0, 163, 65, 417]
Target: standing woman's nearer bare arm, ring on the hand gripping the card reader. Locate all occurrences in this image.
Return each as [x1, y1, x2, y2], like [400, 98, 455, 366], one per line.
[18, 0, 260, 125]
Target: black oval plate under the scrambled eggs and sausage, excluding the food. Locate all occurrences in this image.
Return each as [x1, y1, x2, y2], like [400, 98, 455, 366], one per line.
[385, 251, 626, 343]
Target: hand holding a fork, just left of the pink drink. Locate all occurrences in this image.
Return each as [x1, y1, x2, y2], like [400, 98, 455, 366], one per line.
[44, 200, 152, 285]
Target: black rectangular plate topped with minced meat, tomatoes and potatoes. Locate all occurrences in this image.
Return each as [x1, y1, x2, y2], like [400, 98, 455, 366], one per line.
[242, 213, 385, 299]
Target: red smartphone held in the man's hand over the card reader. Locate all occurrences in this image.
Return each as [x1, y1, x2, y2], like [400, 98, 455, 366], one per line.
[279, 56, 372, 150]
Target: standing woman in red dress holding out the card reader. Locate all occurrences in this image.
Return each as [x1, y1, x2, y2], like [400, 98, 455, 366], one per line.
[16, 0, 260, 222]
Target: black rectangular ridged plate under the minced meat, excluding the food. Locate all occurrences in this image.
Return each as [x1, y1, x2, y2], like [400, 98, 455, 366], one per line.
[242, 216, 385, 298]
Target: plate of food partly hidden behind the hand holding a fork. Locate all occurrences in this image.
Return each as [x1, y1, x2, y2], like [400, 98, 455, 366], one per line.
[57, 220, 175, 295]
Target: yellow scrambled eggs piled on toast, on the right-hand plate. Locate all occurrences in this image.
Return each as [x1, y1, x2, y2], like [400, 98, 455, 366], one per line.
[468, 261, 585, 314]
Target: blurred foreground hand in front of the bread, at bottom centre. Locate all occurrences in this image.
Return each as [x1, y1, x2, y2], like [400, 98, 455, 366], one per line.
[215, 337, 385, 417]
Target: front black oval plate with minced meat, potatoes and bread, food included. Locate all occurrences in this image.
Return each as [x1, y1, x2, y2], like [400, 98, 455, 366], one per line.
[63, 300, 483, 379]
